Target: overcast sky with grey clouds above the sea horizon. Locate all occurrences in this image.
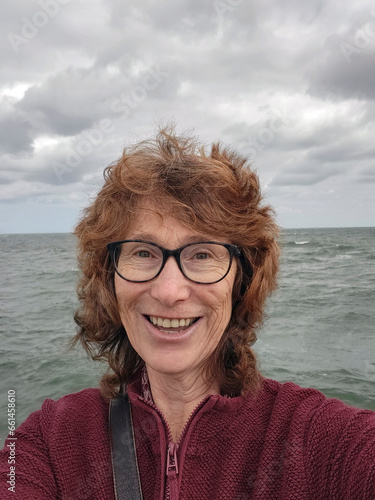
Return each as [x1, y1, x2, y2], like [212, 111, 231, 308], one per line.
[0, 0, 375, 233]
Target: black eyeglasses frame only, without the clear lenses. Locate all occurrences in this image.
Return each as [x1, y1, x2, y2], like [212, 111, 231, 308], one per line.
[107, 240, 241, 285]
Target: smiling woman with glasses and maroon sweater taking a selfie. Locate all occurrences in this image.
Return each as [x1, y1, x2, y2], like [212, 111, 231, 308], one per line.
[2, 129, 375, 500]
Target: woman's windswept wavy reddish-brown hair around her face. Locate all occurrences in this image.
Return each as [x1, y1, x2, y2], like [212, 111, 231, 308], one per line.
[73, 127, 279, 398]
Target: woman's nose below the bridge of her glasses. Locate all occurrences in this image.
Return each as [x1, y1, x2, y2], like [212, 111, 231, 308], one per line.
[150, 257, 191, 306]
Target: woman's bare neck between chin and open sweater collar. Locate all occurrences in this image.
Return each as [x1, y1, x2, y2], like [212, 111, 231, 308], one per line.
[147, 366, 220, 442]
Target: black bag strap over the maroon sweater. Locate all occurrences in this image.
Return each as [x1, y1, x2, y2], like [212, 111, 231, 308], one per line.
[109, 394, 142, 500]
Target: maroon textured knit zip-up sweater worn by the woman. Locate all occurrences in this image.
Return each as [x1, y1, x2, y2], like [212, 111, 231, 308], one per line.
[0, 379, 375, 500]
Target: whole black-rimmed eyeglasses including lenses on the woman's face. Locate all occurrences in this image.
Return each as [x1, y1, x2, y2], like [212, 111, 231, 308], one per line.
[107, 240, 240, 285]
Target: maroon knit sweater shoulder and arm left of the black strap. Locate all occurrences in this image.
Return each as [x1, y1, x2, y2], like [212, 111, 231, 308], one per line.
[0, 389, 112, 498]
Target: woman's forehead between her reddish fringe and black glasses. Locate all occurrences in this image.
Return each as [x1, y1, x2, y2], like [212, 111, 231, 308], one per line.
[125, 201, 225, 248]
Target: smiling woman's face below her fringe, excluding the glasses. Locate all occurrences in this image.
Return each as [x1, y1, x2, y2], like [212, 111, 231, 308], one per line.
[115, 201, 236, 375]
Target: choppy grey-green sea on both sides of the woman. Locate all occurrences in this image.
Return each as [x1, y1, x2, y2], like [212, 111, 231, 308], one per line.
[0, 227, 375, 443]
